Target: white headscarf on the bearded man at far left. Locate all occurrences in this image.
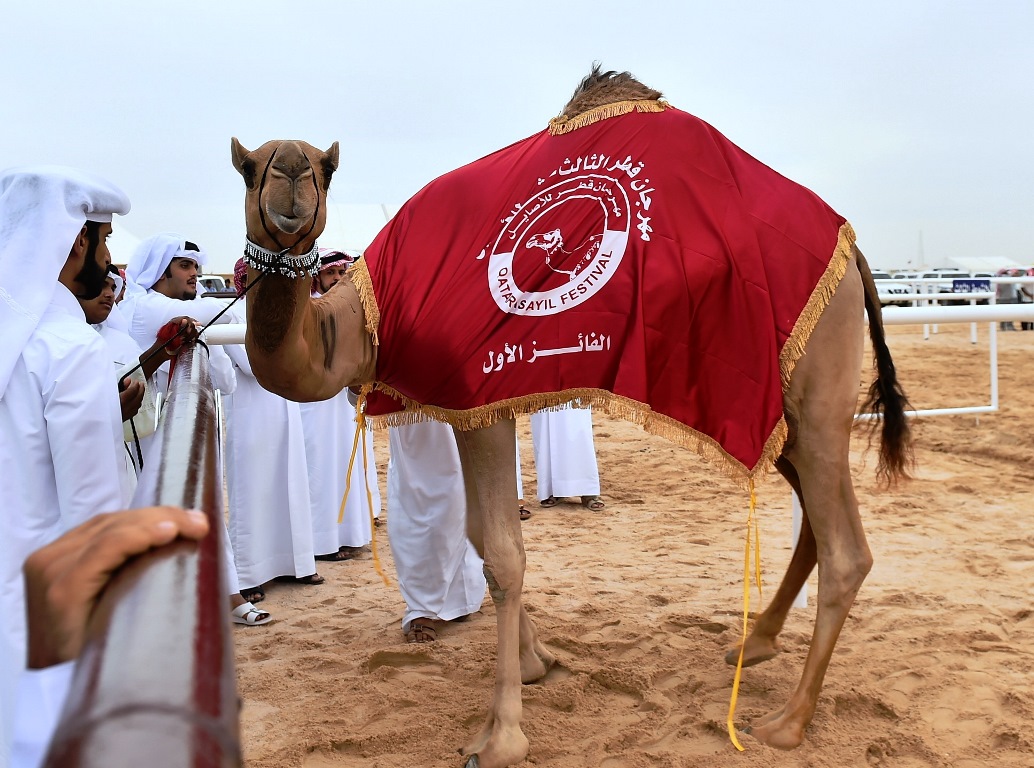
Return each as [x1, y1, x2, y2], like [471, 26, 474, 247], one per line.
[0, 165, 129, 398]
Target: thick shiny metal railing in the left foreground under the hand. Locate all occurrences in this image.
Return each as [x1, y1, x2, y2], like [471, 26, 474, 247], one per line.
[44, 346, 241, 768]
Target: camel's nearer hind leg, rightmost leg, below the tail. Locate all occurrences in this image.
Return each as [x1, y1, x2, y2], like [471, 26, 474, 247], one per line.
[751, 255, 873, 749]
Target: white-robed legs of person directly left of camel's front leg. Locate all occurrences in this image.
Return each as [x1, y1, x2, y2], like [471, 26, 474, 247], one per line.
[388, 422, 487, 643]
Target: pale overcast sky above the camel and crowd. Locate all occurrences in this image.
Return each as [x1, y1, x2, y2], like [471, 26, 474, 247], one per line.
[0, 0, 1034, 272]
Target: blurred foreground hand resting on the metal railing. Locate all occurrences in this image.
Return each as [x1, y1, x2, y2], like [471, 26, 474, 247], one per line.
[23, 506, 208, 669]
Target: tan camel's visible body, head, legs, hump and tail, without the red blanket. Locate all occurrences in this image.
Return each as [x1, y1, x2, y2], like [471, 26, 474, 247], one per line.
[232, 67, 911, 768]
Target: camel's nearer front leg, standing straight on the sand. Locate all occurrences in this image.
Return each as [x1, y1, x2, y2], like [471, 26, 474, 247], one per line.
[456, 420, 530, 768]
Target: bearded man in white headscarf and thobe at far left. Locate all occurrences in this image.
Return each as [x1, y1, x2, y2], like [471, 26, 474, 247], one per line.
[0, 166, 129, 765]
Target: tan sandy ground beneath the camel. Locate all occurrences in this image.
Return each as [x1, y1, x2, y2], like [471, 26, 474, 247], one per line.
[235, 326, 1034, 768]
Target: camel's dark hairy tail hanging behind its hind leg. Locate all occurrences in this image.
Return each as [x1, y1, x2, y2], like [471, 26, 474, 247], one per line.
[855, 248, 914, 484]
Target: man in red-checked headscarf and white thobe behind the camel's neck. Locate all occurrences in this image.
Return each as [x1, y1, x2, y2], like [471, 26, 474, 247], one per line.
[301, 248, 381, 560]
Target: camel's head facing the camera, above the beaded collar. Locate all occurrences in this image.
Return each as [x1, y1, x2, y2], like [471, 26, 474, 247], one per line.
[231, 137, 338, 253]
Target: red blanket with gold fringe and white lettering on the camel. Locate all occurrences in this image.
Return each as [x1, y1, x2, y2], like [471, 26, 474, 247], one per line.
[353, 101, 853, 479]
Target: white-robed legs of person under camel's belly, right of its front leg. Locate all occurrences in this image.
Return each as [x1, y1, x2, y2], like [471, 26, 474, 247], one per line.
[531, 405, 604, 512]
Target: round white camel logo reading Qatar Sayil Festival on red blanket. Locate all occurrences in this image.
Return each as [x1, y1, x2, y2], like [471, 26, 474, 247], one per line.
[488, 174, 631, 317]
